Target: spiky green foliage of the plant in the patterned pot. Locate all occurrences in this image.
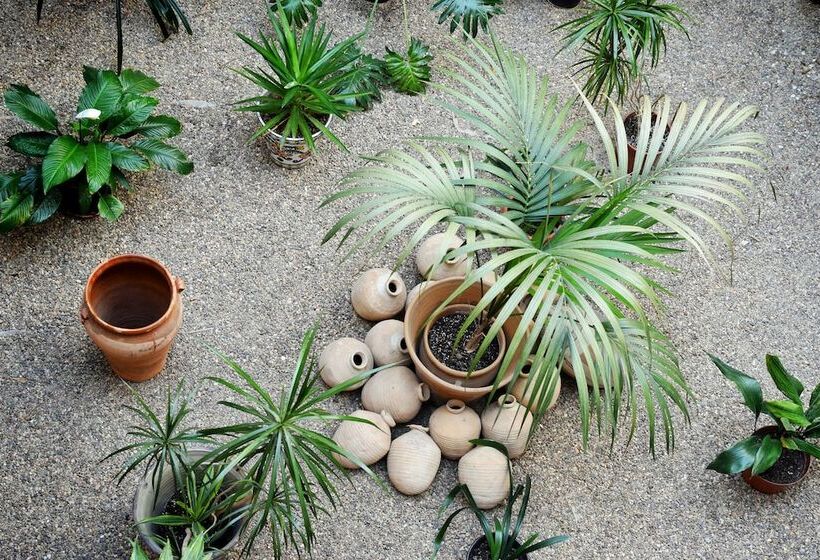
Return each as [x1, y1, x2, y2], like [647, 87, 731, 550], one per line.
[236, 6, 364, 149]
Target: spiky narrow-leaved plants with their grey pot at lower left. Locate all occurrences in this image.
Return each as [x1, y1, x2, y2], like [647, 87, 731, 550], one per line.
[109, 328, 377, 560]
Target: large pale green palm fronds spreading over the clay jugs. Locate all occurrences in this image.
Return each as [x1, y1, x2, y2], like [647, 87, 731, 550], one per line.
[323, 35, 763, 454]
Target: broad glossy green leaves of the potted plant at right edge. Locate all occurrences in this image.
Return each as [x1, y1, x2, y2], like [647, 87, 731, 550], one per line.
[706, 354, 820, 475]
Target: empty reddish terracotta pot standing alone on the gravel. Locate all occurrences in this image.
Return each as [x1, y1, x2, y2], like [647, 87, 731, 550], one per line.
[80, 255, 185, 382]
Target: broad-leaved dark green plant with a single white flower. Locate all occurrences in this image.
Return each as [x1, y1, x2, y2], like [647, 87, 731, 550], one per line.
[0, 66, 193, 232]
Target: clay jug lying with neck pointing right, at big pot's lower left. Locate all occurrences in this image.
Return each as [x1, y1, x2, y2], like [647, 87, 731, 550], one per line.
[362, 366, 430, 423]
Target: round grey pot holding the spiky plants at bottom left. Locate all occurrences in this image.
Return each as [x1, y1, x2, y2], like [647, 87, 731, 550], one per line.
[133, 448, 248, 558]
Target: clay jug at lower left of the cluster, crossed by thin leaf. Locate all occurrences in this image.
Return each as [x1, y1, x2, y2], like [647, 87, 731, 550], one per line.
[333, 410, 396, 469]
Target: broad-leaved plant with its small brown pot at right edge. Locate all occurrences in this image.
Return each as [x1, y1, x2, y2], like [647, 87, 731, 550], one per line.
[706, 354, 820, 494]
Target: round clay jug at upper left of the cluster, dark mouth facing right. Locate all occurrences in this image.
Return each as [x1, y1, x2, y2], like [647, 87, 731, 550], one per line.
[350, 268, 407, 321]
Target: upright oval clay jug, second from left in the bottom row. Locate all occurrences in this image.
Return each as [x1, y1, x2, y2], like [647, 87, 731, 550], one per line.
[387, 425, 441, 496]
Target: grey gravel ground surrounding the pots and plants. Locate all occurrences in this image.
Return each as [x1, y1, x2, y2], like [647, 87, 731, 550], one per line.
[0, 0, 820, 560]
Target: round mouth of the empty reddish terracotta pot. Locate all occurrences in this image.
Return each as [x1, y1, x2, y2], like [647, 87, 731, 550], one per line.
[85, 255, 177, 334]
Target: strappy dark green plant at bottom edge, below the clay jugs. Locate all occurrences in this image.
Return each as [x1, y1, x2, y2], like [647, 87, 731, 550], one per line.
[433, 439, 569, 560]
